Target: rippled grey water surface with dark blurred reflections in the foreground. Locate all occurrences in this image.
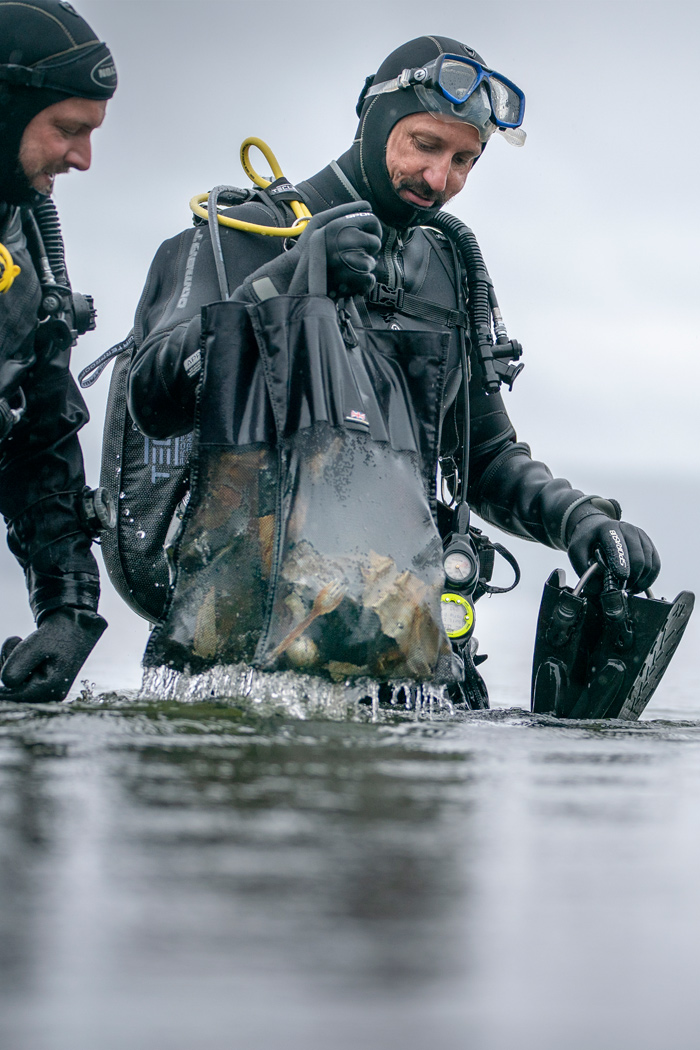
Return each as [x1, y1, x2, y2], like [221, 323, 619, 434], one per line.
[0, 695, 700, 1050]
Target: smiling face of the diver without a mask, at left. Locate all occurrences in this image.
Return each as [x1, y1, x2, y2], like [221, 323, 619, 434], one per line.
[20, 99, 107, 195]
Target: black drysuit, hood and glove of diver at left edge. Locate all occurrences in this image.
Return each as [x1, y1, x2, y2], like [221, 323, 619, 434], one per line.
[0, 0, 116, 702]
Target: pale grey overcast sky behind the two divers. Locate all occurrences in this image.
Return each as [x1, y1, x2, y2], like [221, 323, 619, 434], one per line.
[0, 0, 700, 692]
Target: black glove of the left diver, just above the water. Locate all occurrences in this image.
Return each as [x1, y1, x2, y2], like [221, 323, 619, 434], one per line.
[0, 606, 107, 704]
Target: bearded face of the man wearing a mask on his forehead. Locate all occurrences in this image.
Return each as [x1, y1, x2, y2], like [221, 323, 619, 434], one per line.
[386, 113, 482, 208]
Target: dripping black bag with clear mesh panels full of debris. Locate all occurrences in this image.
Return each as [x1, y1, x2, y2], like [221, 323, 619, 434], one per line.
[145, 295, 452, 683]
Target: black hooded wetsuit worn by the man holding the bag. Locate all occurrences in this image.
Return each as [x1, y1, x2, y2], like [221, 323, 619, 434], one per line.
[129, 37, 660, 659]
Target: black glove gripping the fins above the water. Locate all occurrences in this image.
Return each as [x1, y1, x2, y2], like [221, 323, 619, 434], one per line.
[568, 510, 661, 594]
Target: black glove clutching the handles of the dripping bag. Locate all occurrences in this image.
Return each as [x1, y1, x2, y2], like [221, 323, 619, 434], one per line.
[231, 201, 382, 302]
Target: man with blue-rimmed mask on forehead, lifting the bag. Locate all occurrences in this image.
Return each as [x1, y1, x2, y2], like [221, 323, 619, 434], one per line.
[129, 37, 660, 692]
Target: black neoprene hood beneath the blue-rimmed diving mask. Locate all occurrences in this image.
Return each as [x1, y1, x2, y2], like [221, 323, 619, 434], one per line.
[343, 37, 485, 227]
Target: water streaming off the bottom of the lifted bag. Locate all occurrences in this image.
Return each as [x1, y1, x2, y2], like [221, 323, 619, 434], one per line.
[139, 664, 455, 721]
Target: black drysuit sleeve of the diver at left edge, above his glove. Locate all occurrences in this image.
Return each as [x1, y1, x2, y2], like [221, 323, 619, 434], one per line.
[0, 207, 100, 620]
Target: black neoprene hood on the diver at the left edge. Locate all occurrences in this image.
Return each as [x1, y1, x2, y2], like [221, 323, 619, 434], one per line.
[0, 0, 116, 204]
